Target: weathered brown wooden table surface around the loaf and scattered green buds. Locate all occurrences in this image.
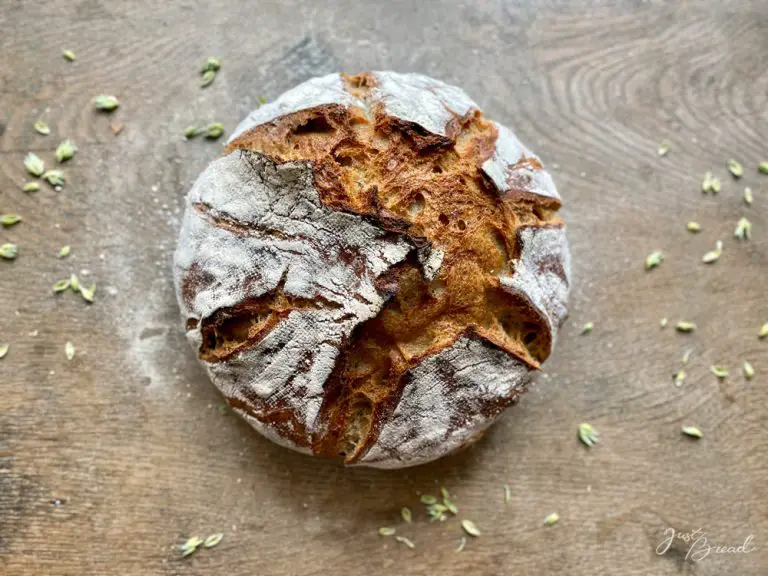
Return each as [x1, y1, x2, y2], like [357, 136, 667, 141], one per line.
[0, 0, 768, 576]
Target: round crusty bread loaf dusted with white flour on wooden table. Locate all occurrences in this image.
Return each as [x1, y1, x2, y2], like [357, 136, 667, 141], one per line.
[174, 72, 570, 468]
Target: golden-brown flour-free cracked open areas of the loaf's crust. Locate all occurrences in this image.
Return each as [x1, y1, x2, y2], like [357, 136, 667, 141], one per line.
[182, 74, 565, 463]
